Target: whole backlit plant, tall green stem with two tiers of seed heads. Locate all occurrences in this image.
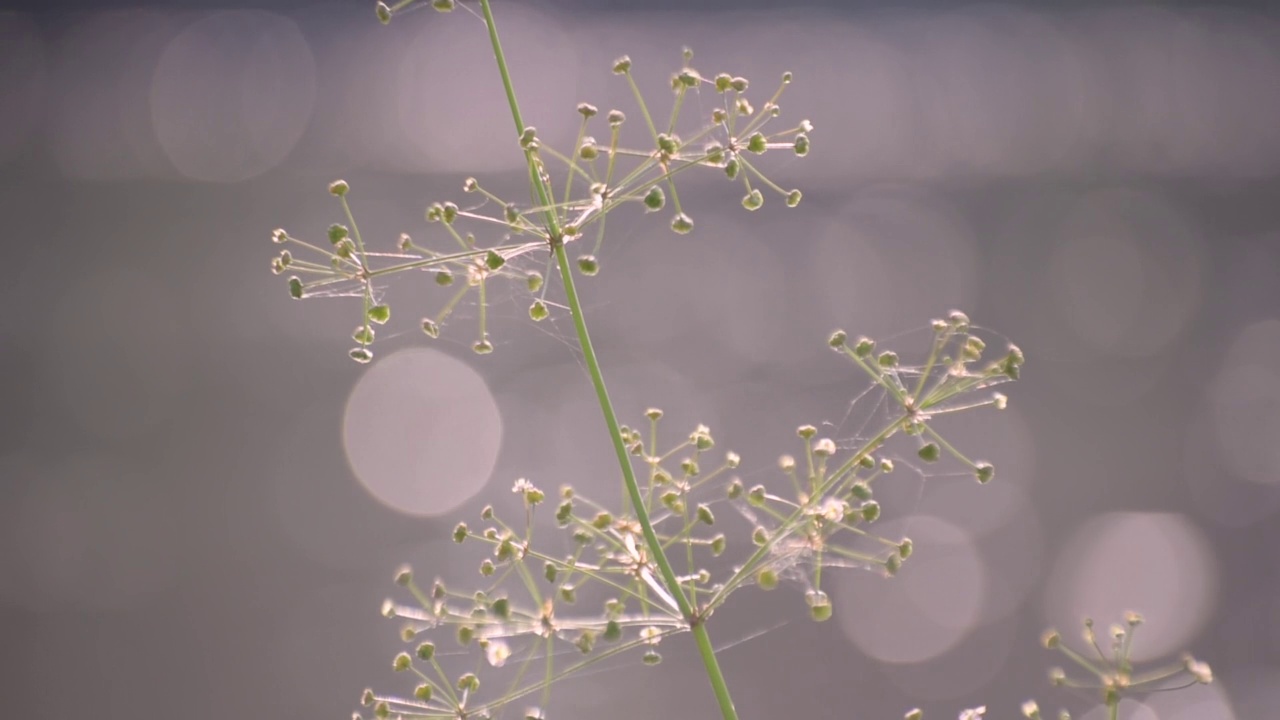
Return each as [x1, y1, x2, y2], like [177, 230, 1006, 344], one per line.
[273, 0, 1207, 720]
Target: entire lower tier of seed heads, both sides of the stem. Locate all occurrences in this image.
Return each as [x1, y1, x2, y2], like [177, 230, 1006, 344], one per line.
[355, 313, 1021, 717]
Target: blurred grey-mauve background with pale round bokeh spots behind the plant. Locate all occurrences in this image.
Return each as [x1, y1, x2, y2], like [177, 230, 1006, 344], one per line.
[0, 0, 1280, 720]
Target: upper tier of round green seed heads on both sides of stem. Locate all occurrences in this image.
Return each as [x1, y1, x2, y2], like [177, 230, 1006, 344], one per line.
[271, 14, 813, 363]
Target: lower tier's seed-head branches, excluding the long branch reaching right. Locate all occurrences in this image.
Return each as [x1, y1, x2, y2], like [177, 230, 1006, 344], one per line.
[362, 410, 739, 717]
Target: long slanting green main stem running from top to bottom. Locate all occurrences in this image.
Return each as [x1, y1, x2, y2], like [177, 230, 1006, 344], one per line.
[480, 0, 737, 720]
